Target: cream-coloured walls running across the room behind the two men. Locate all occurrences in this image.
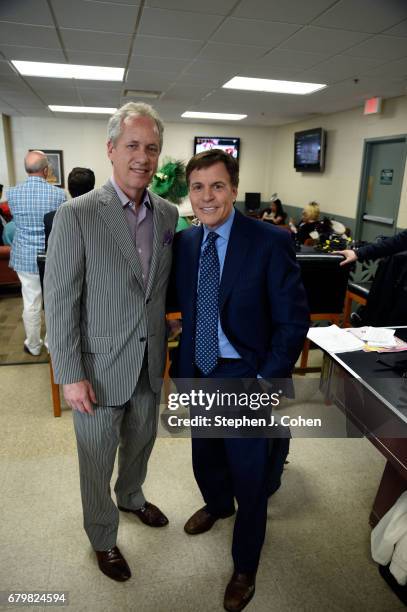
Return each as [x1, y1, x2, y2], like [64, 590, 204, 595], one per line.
[7, 97, 407, 227]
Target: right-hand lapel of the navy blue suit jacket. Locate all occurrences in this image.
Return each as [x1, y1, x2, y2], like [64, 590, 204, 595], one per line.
[219, 211, 250, 312]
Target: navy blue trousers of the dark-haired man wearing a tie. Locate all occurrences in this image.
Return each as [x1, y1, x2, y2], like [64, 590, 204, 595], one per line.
[192, 360, 270, 573]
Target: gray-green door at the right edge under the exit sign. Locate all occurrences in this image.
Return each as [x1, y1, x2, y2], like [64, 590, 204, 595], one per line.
[355, 135, 407, 242]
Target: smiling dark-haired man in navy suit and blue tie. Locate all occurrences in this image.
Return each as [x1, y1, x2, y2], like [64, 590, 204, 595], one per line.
[171, 149, 308, 612]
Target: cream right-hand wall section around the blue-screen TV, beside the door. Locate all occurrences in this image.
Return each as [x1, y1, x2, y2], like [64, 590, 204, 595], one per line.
[268, 96, 407, 227]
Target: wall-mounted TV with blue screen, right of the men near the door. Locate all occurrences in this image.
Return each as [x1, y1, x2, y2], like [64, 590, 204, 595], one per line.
[294, 128, 326, 172]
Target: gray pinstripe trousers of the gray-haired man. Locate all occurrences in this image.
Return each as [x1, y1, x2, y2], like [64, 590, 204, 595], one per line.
[73, 358, 159, 550]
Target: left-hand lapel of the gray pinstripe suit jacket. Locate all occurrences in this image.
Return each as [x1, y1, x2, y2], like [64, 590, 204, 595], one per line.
[99, 182, 144, 291]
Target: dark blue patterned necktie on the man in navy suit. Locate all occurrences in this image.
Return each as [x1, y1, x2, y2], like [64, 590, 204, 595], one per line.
[195, 232, 220, 375]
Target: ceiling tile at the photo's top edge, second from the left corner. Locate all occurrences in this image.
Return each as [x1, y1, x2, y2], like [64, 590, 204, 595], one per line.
[52, 0, 139, 34]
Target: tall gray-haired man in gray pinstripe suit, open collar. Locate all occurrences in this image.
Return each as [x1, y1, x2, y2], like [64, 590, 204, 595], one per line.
[45, 103, 178, 581]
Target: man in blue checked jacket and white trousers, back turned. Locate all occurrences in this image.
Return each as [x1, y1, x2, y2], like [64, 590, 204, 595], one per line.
[7, 151, 67, 355]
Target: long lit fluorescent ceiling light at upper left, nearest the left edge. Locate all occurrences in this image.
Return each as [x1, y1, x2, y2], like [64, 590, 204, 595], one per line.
[11, 60, 124, 81]
